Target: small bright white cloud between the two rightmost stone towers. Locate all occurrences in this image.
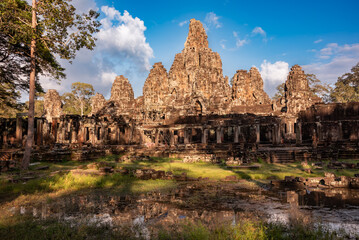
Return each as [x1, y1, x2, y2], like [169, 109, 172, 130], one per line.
[260, 60, 289, 96]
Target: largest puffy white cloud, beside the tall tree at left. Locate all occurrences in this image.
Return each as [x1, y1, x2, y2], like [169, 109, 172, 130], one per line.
[37, 5, 153, 99]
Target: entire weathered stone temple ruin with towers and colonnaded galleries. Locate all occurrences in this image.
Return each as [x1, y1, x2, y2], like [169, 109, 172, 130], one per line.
[0, 19, 359, 163]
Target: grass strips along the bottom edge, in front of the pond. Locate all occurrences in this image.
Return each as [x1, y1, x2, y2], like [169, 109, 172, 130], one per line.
[0, 216, 345, 240]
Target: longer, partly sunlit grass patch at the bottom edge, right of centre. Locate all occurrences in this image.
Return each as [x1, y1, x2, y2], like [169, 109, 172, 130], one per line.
[156, 218, 344, 240]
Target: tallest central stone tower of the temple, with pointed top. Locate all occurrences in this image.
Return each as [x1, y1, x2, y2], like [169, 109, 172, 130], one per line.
[169, 19, 230, 112]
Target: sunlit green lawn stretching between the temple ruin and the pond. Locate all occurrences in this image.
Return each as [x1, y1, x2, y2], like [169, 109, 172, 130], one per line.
[0, 155, 359, 202]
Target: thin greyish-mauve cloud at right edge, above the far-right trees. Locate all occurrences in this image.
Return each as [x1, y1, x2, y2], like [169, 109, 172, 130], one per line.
[303, 43, 359, 84]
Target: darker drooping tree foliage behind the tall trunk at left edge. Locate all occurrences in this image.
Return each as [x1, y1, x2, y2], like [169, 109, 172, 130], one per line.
[0, 0, 64, 111]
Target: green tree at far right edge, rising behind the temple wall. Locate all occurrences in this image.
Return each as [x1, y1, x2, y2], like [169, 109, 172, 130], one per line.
[330, 63, 359, 103]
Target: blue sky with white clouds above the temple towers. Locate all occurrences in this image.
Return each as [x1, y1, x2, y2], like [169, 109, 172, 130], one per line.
[36, 0, 359, 98]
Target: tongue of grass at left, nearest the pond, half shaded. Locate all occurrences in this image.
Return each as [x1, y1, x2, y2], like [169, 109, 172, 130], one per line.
[0, 172, 177, 205]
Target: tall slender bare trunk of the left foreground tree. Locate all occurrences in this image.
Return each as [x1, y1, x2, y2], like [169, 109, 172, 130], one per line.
[21, 0, 37, 170]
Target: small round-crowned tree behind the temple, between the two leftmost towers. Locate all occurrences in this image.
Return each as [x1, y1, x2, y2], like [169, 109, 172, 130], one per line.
[61, 82, 95, 115]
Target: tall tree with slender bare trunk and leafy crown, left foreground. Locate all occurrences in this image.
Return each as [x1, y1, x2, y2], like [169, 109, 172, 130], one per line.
[0, 0, 100, 169]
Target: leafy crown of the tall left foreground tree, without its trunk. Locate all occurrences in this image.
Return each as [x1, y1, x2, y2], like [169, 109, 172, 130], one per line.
[0, 0, 100, 117]
